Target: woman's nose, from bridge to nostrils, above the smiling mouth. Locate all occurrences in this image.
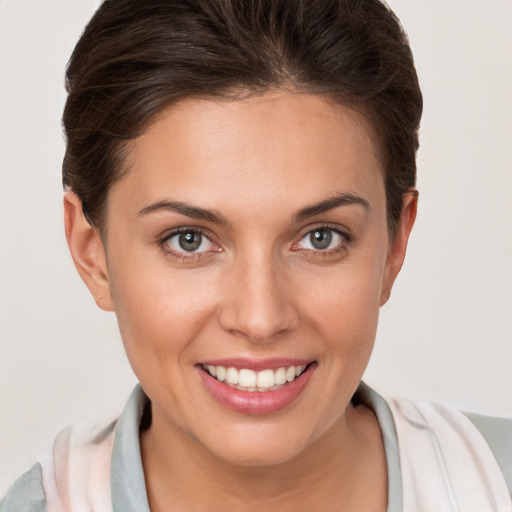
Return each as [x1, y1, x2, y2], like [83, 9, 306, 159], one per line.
[219, 249, 299, 343]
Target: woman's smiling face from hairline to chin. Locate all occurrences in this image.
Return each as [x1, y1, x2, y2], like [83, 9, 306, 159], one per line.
[84, 91, 414, 465]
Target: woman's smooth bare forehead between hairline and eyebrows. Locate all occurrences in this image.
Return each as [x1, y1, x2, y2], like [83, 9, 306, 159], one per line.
[113, 91, 383, 218]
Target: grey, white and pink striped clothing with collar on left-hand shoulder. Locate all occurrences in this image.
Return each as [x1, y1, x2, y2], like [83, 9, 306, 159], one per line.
[0, 385, 149, 512]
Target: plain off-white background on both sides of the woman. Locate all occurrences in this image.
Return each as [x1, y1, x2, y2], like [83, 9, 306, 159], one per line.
[0, 0, 512, 495]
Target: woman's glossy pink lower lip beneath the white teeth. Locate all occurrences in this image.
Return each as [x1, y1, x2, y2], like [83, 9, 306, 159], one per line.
[197, 364, 316, 414]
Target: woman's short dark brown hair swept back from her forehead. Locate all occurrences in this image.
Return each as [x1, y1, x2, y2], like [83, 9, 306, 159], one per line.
[63, 0, 422, 233]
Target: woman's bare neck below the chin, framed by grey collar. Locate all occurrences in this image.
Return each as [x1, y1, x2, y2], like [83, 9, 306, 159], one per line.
[141, 406, 387, 512]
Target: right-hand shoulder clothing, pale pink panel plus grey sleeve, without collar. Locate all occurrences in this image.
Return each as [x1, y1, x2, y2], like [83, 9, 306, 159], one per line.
[387, 399, 512, 511]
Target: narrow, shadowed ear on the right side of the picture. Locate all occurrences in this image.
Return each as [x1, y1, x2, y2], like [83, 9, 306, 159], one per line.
[380, 189, 418, 306]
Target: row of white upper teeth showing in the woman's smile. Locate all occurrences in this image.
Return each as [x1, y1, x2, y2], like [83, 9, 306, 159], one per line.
[201, 361, 314, 392]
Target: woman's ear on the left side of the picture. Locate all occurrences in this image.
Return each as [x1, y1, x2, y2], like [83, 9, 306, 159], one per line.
[64, 191, 113, 311]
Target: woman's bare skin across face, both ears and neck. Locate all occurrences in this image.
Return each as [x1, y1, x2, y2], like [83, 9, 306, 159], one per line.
[65, 91, 416, 512]
